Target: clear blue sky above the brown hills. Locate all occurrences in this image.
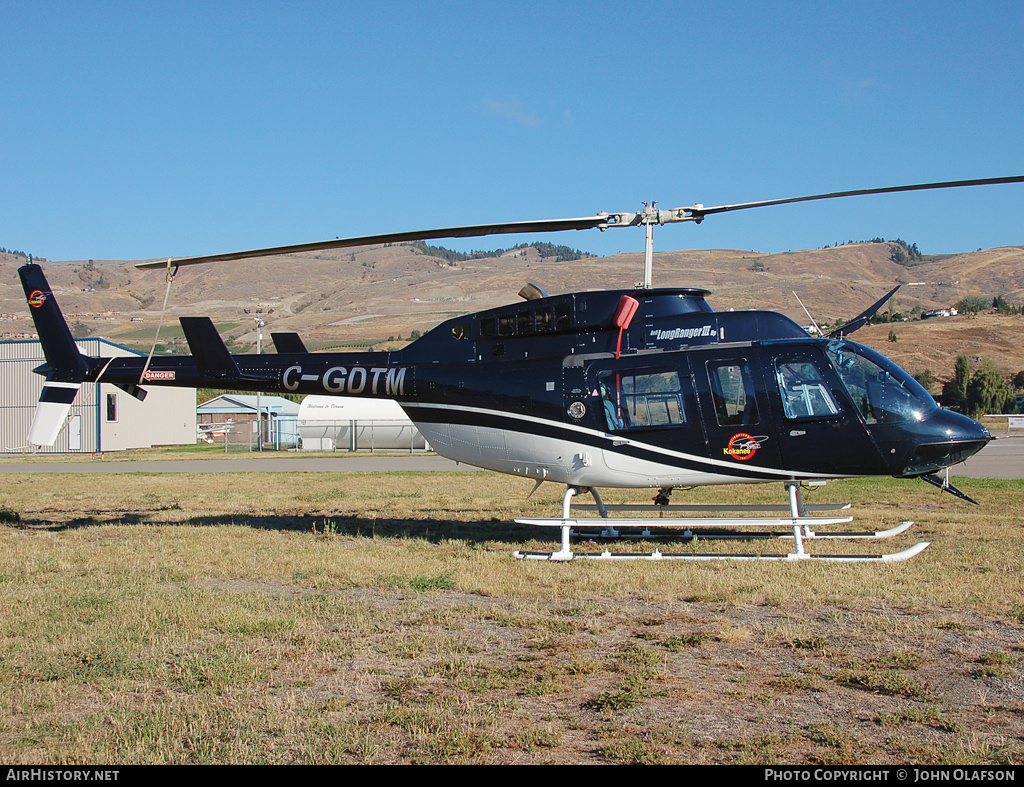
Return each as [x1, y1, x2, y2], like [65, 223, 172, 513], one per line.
[0, 0, 1024, 260]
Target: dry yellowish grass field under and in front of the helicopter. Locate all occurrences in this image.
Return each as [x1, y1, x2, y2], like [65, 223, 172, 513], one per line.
[0, 465, 1024, 763]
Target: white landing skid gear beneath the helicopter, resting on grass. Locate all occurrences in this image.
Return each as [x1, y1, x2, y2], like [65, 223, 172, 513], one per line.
[513, 482, 929, 563]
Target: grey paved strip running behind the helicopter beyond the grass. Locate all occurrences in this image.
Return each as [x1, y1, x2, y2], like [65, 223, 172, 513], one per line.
[0, 437, 1024, 479]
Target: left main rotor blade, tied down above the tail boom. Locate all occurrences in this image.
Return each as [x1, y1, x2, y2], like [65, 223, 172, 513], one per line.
[135, 215, 614, 269]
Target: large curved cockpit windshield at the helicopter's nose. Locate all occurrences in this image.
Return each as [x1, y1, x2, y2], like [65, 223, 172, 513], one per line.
[827, 341, 939, 424]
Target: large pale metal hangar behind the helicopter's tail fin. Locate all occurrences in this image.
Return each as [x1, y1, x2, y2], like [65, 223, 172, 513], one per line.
[0, 339, 197, 453]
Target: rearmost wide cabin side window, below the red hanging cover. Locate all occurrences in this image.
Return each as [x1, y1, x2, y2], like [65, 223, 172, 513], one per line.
[598, 371, 686, 431]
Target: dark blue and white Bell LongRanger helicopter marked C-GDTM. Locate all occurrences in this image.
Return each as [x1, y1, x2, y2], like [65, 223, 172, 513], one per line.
[18, 176, 1024, 562]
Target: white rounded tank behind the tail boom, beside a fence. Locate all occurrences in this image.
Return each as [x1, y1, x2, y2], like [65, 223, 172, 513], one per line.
[298, 396, 429, 451]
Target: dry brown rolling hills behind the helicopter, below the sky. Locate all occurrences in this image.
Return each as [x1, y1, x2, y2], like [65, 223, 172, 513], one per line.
[0, 243, 1024, 379]
